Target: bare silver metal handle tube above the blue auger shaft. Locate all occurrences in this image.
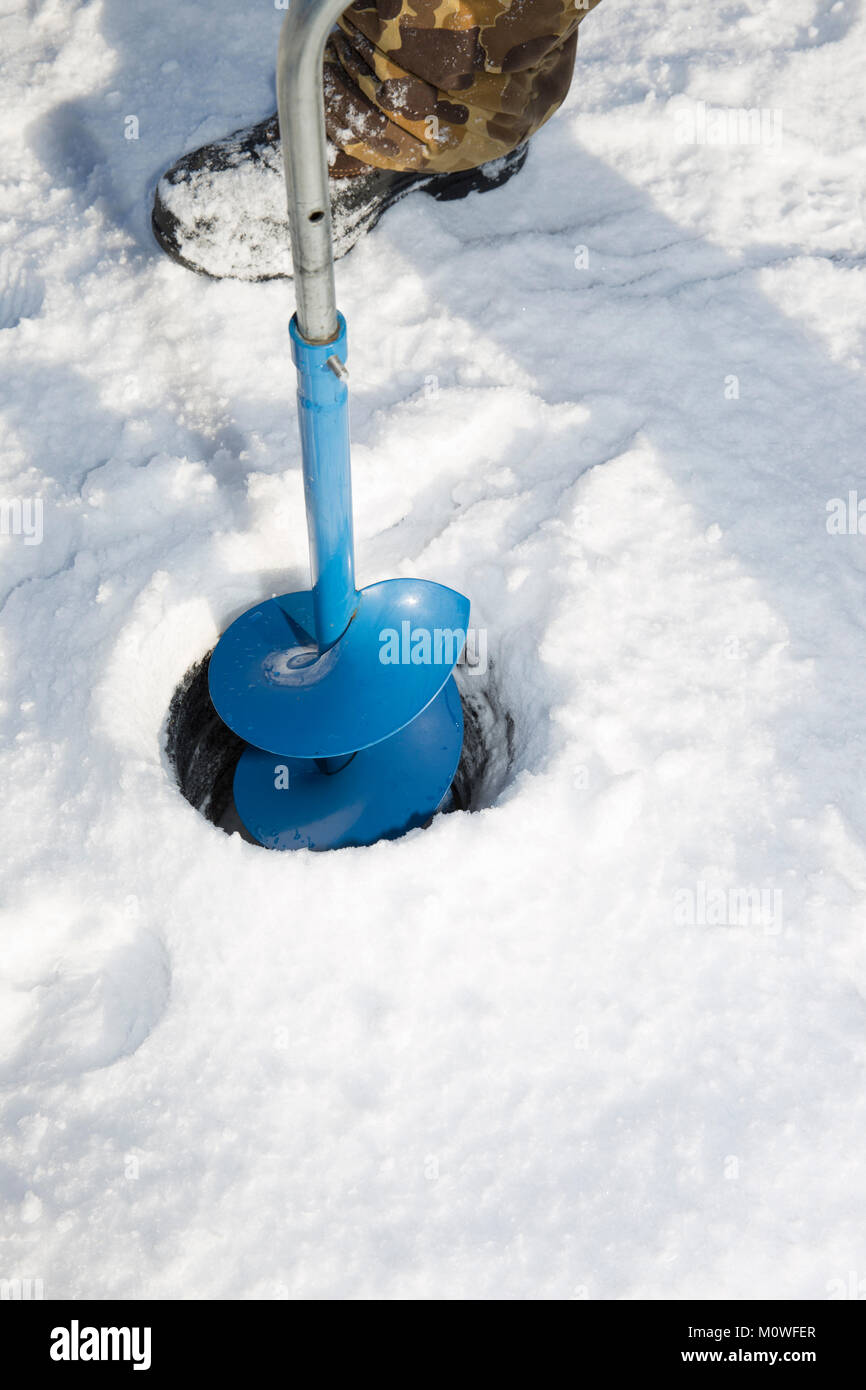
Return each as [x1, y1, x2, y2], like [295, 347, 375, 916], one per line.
[277, 0, 348, 343]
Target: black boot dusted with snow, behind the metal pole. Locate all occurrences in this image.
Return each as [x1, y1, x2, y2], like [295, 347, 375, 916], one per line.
[153, 115, 527, 281]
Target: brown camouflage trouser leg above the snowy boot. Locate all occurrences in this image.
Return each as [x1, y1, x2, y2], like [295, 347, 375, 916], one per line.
[325, 0, 598, 172]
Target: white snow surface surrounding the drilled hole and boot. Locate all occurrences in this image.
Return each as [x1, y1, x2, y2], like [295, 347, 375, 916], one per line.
[0, 0, 866, 1300]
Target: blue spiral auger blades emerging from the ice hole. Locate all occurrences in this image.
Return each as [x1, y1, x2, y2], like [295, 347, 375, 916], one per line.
[209, 580, 468, 849]
